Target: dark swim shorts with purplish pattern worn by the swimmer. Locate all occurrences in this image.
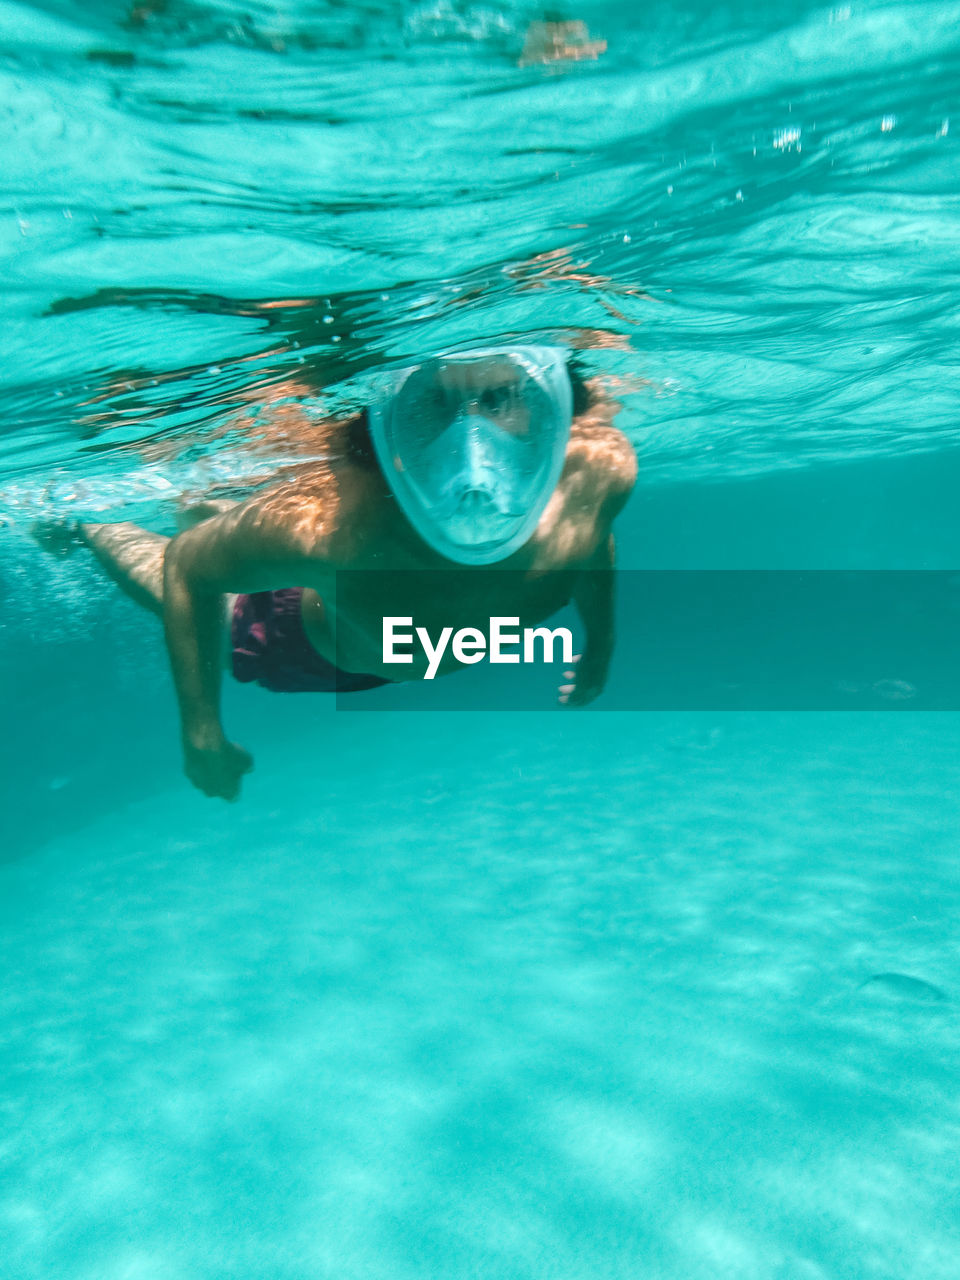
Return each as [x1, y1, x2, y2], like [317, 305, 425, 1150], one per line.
[230, 586, 389, 694]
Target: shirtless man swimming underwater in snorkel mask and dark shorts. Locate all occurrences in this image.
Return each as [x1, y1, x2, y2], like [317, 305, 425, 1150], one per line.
[60, 346, 636, 800]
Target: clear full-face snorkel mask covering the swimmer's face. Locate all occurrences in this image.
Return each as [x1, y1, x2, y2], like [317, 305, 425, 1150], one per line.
[370, 347, 573, 564]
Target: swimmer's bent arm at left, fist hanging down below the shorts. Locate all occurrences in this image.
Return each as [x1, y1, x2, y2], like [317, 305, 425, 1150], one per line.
[164, 503, 324, 800]
